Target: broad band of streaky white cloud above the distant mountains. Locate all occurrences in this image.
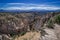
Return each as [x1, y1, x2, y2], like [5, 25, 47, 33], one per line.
[1, 3, 60, 10]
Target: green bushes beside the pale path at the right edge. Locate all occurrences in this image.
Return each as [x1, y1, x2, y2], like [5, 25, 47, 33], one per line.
[47, 14, 60, 28]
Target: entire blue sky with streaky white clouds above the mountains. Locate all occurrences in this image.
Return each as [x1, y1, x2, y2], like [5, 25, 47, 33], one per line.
[0, 0, 60, 10]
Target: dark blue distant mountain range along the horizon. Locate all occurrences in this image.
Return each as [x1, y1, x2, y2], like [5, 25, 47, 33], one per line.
[0, 9, 60, 12]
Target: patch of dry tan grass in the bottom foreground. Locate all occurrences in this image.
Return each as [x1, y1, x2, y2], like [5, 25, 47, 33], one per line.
[14, 32, 40, 40]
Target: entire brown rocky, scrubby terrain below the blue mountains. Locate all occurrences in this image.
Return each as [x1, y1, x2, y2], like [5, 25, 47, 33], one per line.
[0, 12, 60, 40]
